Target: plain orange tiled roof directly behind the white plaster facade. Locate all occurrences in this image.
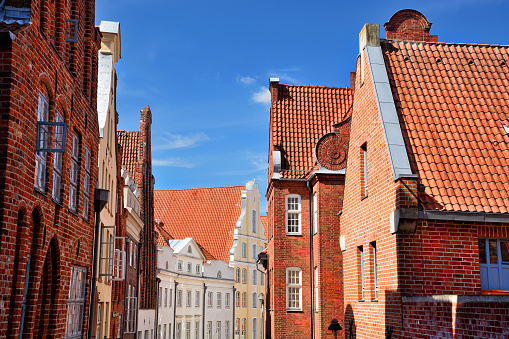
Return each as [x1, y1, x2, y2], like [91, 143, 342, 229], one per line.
[154, 186, 245, 262]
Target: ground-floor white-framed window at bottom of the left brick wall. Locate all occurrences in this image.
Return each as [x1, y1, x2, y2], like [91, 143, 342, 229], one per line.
[65, 266, 87, 338]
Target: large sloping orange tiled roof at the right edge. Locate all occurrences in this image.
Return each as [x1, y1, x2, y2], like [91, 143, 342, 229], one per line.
[382, 41, 509, 213]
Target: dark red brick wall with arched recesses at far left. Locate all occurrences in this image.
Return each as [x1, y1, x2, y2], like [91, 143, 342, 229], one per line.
[0, 1, 100, 338]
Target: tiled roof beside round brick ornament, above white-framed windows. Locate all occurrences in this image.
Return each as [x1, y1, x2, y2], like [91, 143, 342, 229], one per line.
[270, 84, 352, 178]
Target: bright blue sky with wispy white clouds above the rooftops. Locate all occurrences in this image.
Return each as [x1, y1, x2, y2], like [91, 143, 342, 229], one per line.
[96, 0, 509, 214]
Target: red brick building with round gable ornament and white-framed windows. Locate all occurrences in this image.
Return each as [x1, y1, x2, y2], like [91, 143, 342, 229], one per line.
[264, 79, 353, 338]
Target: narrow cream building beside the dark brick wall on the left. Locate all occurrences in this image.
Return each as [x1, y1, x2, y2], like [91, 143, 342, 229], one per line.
[95, 21, 120, 338]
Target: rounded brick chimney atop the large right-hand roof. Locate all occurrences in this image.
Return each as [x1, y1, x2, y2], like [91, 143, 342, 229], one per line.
[384, 9, 438, 42]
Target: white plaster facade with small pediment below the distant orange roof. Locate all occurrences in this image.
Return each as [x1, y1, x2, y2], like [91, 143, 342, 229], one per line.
[157, 238, 234, 339]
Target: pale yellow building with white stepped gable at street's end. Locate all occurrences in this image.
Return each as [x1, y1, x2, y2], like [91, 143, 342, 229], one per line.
[230, 180, 265, 339]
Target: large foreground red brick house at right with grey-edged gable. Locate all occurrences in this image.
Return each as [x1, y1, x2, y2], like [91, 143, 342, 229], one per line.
[341, 10, 509, 338]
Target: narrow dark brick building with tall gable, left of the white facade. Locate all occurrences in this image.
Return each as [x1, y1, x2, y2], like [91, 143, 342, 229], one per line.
[117, 106, 157, 332]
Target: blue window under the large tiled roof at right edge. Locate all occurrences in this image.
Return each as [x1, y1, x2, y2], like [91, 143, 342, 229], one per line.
[478, 239, 509, 291]
